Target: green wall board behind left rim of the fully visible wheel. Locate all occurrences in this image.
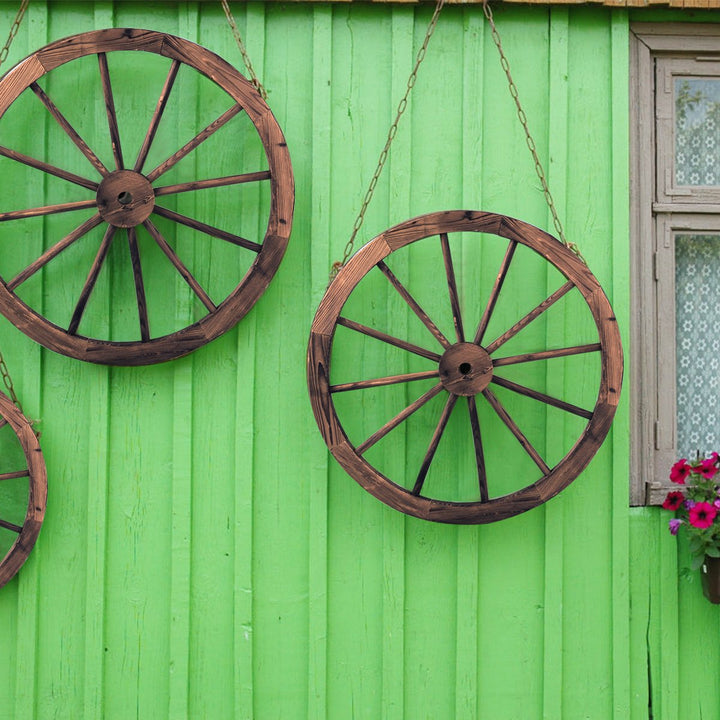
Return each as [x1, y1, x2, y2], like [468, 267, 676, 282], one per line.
[327, 4, 390, 718]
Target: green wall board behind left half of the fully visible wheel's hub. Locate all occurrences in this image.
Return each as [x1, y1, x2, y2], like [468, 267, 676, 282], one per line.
[402, 6, 464, 717]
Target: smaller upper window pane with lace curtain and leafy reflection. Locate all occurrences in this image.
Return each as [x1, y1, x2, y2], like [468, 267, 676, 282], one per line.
[675, 77, 720, 185]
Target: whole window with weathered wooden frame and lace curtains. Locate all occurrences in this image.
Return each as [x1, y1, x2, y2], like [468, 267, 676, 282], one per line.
[630, 23, 720, 505]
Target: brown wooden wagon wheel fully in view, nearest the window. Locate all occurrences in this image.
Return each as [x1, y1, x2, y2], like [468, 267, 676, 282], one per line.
[307, 211, 623, 524]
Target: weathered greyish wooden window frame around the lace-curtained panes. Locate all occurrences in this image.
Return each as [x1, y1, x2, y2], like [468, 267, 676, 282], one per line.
[630, 22, 720, 505]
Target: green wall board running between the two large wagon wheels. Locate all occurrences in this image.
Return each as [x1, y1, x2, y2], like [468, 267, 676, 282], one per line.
[251, 4, 312, 717]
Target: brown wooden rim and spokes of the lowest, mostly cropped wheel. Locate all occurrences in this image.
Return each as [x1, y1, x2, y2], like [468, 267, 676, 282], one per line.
[0, 393, 47, 587]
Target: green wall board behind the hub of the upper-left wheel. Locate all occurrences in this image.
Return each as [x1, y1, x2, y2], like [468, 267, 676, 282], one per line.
[101, 3, 176, 717]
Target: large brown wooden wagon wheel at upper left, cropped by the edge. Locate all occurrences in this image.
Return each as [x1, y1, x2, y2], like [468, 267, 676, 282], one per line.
[0, 28, 294, 365]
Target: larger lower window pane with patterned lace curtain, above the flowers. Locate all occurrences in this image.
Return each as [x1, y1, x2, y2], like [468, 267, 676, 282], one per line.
[676, 234, 720, 459]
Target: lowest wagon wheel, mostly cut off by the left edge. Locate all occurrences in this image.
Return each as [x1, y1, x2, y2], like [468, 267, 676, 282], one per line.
[0, 393, 47, 587]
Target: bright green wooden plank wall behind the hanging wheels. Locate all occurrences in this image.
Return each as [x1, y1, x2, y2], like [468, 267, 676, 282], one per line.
[0, 0, 720, 720]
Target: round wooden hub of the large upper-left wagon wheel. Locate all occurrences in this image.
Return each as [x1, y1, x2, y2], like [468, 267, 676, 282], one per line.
[97, 170, 155, 228]
